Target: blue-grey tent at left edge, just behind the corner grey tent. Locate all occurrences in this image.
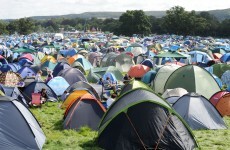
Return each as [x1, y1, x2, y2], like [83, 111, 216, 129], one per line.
[0, 84, 28, 107]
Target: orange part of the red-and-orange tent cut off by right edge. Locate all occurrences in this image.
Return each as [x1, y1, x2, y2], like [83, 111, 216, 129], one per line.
[216, 93, 230, 116]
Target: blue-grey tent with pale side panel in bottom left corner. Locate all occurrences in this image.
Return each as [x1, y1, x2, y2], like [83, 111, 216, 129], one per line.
[0, 96, 46, 150]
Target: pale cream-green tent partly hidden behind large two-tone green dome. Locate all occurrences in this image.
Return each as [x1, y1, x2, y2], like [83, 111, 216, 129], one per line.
[152, 64, 180, 94]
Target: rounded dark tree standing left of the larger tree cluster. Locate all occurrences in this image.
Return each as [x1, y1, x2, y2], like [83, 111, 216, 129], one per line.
[119, 10, 151, 36]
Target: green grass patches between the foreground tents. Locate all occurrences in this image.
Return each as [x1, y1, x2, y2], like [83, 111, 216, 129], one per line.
[31, 102, 230, 150]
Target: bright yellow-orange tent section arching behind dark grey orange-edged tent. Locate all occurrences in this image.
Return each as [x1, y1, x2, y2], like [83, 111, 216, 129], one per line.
[61, 90, 88, 108]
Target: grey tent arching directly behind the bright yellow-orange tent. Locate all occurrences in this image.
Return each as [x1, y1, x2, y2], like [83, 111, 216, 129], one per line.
[66, 81, 101, 100]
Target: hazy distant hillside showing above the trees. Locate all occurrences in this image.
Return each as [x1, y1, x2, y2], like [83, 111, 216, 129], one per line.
[28, 8, 230, 20]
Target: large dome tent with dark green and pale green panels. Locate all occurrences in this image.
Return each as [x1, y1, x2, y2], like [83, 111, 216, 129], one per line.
[164, 65, 220, 99]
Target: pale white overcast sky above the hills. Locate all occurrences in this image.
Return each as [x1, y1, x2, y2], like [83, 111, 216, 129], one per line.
[0, 0, 230, 19]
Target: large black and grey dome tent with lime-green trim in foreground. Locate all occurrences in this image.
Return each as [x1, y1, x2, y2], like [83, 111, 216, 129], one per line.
[98, 89, 199, 150]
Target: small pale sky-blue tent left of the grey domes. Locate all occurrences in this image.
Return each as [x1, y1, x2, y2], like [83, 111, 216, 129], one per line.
[47, 77, 69, 96]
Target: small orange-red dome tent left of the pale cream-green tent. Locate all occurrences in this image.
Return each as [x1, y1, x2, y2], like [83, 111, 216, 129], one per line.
[128, 64, 150, 78]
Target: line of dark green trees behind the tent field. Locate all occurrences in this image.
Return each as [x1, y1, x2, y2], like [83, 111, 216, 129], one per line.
[0, 6, 230, 37]
